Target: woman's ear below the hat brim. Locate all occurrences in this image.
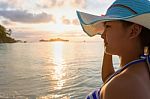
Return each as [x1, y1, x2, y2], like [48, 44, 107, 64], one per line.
[129, 24, 142, 39]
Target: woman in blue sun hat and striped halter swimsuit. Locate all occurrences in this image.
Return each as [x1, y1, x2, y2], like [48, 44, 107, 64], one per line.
[77, 0, 150, 99]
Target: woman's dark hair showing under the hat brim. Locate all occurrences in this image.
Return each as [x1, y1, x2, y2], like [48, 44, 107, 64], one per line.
[121, 20, 150, 49]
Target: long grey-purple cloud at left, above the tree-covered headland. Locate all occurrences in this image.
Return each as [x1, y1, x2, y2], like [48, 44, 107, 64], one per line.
[0, 10, 55, 23]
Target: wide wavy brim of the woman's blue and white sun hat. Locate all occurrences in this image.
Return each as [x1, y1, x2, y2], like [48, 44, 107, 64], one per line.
[77, 11, 150, 36]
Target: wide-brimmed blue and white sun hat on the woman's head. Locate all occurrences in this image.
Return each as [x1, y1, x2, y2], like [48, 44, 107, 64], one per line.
[77, 0, 150, 36]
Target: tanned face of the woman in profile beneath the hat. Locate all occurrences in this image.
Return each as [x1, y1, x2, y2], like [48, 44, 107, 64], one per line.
[101, 21, 130, 55]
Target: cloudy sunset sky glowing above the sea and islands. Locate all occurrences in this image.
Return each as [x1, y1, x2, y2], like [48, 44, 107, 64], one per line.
[0, 0, 114, 41]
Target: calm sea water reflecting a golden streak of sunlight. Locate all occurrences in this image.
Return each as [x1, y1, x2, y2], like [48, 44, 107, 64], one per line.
[0, 41, 119, 99]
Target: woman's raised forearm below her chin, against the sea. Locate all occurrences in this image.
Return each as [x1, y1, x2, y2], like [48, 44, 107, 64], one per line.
[102, 53, 115, 82]
